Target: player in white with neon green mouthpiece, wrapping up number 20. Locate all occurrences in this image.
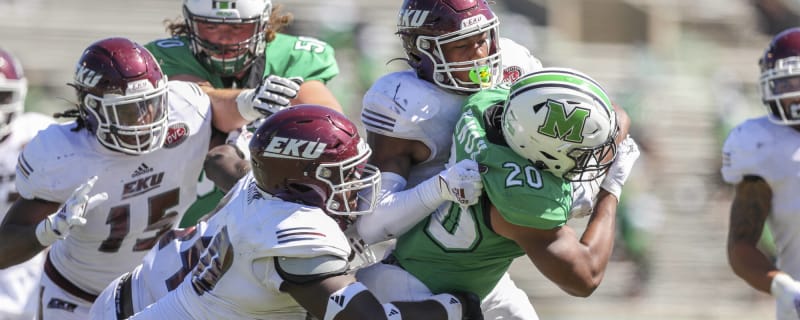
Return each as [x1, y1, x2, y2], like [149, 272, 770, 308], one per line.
[357, 0, 600, 319]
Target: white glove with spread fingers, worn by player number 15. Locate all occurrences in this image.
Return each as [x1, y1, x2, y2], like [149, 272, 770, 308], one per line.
[36, 176, 108, 247]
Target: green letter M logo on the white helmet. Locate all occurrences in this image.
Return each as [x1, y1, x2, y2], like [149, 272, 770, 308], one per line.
[533, 99, 591, 143]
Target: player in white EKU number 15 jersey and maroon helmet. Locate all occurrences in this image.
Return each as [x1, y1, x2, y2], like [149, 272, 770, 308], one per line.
[0, 38, 272, 319]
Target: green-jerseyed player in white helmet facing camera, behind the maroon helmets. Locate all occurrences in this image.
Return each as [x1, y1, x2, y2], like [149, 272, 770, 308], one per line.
[145, 0, 342, 226]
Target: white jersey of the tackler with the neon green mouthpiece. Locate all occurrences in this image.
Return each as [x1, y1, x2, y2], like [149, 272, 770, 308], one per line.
[361, 38, 542, 188]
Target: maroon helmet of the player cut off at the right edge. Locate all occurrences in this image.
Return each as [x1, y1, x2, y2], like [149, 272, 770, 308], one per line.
[759, 28, 800, 125]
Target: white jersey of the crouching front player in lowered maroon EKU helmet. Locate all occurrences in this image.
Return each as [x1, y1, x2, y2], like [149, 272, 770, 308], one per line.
[133, 173, 350, 319]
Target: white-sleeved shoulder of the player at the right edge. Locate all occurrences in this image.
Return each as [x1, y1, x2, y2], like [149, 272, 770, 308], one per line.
[721, 117, 780, 184]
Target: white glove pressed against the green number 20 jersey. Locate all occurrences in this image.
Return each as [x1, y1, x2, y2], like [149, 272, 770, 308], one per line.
[419, 159, 483, 209]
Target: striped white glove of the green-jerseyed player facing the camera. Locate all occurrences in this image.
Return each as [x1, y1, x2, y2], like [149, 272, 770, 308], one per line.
[236, 75, 303, 121]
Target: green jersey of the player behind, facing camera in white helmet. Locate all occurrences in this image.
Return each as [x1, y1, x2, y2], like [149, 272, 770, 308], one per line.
[145, 33, 339, 227]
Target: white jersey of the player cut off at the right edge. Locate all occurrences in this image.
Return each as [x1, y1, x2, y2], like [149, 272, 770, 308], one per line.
[722, 117, 800, 279]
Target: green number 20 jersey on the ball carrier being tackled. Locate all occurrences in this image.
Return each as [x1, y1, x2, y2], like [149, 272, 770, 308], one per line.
[394, 89, 572, 299]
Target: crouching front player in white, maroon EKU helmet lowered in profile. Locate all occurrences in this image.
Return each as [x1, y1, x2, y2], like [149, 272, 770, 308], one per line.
[101, 105, 482, 320]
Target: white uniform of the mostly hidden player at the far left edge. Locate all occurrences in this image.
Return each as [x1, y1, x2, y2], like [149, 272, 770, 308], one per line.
[0, 112, 55, 319]
